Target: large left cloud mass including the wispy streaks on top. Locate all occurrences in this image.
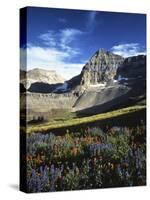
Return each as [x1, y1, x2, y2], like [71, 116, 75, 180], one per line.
[21, 28, 83, 79]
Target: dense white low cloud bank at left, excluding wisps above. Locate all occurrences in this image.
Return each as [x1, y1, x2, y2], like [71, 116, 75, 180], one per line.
[21, 45, 84, 79]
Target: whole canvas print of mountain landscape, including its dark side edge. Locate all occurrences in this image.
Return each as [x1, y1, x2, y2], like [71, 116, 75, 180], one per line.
[20, 7, 146, 193]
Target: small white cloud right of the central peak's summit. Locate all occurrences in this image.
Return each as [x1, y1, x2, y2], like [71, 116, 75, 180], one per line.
[111, 43, 146, 57]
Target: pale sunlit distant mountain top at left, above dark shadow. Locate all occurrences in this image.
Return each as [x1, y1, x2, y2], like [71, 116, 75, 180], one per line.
[21, 68, 65, 89]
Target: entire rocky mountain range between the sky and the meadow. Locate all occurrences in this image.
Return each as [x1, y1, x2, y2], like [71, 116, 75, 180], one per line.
[19, 49, 146, 120]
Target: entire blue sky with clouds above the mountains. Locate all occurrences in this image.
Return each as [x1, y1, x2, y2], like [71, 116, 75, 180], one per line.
[21, 7, 146, 79]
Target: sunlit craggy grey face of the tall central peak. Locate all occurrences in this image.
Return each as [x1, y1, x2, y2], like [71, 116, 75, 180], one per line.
[80, 49, 124, 86]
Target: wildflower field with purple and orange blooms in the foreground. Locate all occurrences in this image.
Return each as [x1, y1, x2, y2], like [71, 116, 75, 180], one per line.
[27, 125, 146, 192]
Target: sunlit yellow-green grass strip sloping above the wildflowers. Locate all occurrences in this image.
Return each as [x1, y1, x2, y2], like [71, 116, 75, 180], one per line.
[27, 105, 146, 134]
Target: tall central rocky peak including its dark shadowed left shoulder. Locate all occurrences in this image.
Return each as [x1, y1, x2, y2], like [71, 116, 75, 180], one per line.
[68, 49, 124, 92]
